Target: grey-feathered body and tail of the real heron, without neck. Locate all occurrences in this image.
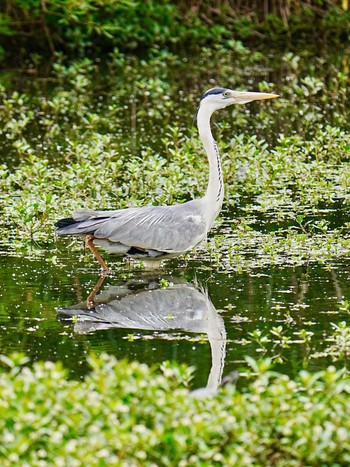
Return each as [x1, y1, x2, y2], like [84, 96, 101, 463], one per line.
[57, 200, 206, 257]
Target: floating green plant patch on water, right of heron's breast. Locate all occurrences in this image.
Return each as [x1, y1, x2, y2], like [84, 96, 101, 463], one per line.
[202, 217, 350, 272]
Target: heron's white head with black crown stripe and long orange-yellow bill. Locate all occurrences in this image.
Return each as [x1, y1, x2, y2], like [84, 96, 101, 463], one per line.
[200, 88, 278, 112]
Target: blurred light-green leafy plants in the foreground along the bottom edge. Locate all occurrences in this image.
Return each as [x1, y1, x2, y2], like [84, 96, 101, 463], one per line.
[0, 356, 350, 467]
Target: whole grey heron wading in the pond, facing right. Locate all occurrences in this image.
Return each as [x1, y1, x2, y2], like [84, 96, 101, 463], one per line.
[55, 87, 278, 271]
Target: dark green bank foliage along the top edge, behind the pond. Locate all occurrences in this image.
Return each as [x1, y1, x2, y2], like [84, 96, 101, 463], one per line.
[0, 0, 349, 56]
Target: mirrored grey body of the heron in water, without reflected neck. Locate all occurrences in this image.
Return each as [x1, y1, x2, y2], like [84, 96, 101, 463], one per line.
[58, 281, 216, 333]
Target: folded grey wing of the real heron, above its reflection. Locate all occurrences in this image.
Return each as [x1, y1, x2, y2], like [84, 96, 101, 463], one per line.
[94, 203, 206, 253]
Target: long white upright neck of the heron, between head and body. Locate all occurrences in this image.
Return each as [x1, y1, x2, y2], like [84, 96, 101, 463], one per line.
[197, 107, 224, 228]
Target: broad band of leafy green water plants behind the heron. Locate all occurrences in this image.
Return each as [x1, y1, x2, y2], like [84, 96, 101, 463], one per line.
[0, 49, 350, 270]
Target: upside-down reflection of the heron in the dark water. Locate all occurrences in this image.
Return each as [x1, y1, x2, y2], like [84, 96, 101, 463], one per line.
[57, 277, 226, 395]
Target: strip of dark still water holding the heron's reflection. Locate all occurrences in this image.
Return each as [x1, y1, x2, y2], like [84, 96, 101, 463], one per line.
[0, 228, 350, 387]
